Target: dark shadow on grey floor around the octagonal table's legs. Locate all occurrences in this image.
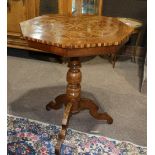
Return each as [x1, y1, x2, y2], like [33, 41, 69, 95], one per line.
[8, 86, 108, 132]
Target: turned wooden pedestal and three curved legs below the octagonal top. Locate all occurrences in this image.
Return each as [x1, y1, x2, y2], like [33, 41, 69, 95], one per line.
[46, 58, 113, 155]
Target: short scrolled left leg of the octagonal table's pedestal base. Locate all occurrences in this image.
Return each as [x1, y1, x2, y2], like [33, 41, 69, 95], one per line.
[46, 94, 67, 111]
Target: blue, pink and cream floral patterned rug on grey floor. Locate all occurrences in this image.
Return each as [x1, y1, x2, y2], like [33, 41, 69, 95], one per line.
[7, 115, 147, 155]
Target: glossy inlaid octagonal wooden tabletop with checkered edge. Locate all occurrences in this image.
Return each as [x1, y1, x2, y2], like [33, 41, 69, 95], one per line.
[20, 14, 133, 56]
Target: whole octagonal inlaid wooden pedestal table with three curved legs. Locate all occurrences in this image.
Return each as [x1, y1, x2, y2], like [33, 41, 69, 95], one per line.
[20, 15, 133, 153]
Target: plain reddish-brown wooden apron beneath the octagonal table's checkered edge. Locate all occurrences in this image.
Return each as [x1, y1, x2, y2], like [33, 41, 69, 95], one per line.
[28, 40, 124, 57]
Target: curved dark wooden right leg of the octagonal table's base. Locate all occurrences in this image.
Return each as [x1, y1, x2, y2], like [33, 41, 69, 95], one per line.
[80, 98, 113, 124]
